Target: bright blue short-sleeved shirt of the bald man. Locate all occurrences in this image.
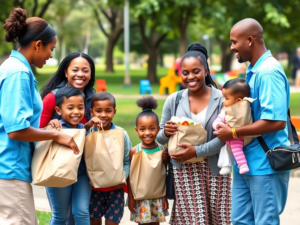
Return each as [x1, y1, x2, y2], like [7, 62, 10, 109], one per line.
[234, 51, 290, 175]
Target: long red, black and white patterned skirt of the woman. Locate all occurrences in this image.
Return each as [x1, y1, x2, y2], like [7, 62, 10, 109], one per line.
[170, 159, 231, 225]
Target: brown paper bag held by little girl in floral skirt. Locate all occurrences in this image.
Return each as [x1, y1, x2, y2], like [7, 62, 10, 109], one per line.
[129, 146, 166, 200]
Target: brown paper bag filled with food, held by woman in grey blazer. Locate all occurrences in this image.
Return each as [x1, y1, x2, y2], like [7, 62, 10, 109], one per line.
[168, 124, 207, 162]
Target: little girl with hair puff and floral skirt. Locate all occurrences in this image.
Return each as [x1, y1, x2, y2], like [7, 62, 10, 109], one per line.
[127, 97, 169, 225]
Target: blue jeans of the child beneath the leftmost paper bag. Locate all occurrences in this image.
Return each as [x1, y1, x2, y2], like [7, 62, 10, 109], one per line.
[46, 172, 92, 225]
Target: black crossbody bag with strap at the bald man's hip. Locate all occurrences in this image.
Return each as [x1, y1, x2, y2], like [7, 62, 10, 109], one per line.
[257, 110, 300, 171]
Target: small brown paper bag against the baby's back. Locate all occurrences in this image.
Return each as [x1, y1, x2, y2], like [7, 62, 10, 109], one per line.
[224, 98, 255, 146]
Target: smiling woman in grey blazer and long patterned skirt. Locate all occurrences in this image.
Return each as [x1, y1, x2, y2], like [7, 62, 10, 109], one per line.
[157, 43, 231, 225]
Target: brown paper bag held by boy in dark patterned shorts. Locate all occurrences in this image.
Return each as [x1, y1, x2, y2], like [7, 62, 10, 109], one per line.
[84, 129, 126, 188]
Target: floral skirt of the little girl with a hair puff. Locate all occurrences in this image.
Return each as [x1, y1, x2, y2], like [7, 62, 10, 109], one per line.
[130, 198, 169, 224]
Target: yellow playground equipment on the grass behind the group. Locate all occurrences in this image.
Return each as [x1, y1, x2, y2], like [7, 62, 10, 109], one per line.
[159, 68, 182, 95]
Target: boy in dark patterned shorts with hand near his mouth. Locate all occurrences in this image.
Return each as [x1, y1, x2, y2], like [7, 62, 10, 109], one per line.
[85, 92, 132, 225]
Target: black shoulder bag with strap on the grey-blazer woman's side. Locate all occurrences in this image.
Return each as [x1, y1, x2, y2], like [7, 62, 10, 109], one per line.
[166, 91, 183, 200]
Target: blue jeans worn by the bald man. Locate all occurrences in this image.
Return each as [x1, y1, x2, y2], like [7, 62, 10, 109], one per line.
[231, 171, 290, 225]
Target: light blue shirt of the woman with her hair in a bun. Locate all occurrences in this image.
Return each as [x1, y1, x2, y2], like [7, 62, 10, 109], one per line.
[0, 51, 43, 182]
